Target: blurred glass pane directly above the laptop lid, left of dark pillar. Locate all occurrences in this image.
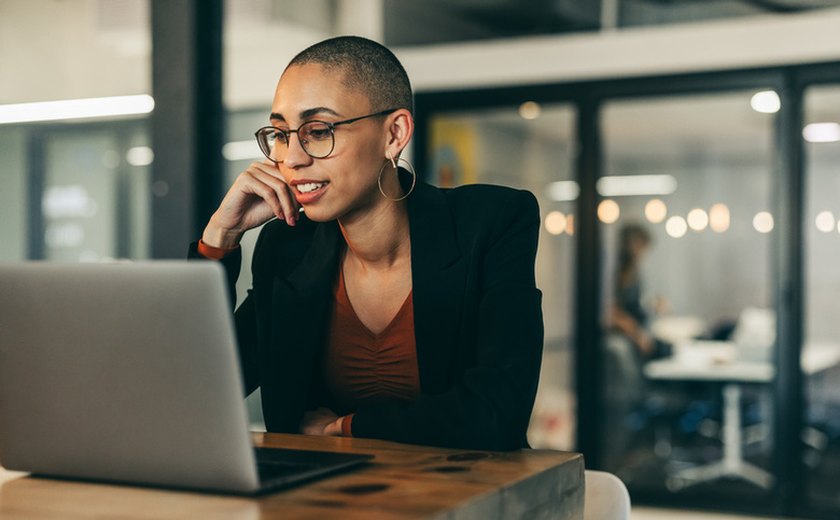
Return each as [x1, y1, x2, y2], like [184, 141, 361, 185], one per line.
[41, 124, 154, 262]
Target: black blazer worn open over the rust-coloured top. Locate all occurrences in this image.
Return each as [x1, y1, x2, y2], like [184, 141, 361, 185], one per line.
[190, 179, 543, 450]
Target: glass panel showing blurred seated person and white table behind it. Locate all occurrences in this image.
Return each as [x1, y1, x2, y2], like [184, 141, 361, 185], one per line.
[597, 91, 779, 501]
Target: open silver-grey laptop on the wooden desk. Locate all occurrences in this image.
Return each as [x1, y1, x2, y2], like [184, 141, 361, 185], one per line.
[0, 262, 373, 495]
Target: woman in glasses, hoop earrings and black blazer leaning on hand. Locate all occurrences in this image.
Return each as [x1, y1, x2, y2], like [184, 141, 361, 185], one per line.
[191, 37, 543, 450]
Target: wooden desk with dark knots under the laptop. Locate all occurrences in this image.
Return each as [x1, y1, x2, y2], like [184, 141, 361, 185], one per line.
[0, 434, 584, 520]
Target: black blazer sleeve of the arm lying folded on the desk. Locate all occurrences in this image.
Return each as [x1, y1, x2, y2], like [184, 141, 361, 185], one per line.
[353, 192, 543, 450]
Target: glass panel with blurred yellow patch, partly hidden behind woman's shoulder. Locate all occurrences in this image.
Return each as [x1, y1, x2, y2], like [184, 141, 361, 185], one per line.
[426, 102, 579, 449]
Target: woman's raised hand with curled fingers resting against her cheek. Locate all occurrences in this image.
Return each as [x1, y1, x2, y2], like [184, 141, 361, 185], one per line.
[201, 160, 300, 248]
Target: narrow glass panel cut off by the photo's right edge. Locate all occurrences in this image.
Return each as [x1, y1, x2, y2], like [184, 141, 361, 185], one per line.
[802, 84, 840, 516]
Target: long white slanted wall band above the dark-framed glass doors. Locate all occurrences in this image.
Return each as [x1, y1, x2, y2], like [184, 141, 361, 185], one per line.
[397, 9, 840, 91]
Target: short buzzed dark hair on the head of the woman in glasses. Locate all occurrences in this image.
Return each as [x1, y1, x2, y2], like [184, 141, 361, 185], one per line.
[286, 36, 414, 114]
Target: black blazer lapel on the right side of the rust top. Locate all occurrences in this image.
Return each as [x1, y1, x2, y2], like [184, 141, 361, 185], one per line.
[408, 182, 467, 394]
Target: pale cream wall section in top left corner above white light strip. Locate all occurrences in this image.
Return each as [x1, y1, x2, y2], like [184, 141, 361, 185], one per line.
[0, 0, 151, 104]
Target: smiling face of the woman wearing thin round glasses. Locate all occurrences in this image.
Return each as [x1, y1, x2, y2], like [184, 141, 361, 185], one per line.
[271, 64, 392, 222]
